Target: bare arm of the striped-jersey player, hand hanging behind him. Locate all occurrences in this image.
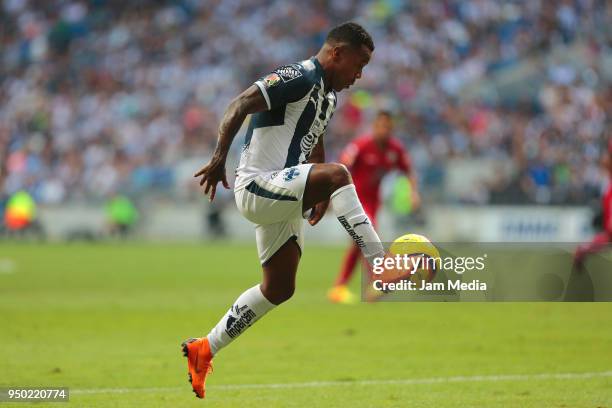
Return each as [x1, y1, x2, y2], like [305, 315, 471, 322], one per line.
[194, 85, 268, 201]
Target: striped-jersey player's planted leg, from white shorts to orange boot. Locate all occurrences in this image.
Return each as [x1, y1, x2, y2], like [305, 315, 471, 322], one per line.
[183, 178, 309, 398]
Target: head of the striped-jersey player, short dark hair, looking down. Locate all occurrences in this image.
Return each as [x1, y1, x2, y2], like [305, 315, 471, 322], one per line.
[322, 22, 374, 92]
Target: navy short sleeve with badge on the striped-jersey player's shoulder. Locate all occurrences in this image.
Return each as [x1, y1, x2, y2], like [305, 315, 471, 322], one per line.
[255, 64, 312, 110]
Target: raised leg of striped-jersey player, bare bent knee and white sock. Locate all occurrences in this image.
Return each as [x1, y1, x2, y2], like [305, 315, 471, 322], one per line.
[302, 163, 384, 263]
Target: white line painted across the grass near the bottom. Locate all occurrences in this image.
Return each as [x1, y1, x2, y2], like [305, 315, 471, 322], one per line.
[70, 371, 612, 394]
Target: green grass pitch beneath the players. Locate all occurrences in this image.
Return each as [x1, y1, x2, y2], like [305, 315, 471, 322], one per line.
[0, 243, 612, 408]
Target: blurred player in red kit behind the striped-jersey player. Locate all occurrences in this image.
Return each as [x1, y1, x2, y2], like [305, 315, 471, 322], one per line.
[328, 111, 420, 303]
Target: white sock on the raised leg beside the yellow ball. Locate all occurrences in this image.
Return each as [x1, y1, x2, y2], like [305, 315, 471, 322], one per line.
[330, 184, 385, 264]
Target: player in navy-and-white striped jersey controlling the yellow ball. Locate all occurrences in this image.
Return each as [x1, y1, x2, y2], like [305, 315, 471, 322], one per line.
[183, 22, 384, 398]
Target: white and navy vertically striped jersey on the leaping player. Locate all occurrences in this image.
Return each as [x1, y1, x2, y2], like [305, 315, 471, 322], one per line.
[236, 57, 337, 188]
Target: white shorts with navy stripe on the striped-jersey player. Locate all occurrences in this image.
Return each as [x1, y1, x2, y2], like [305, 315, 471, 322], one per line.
[234, 164, 312, 265]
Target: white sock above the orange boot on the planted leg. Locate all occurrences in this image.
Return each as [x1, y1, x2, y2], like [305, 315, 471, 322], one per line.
[207, 284, 276, 355]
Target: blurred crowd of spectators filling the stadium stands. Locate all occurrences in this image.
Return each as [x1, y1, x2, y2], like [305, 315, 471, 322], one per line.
[0, 0, 612, 204]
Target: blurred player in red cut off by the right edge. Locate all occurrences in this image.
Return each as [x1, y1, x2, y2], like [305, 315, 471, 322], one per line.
[574, 139, 612, 272]
